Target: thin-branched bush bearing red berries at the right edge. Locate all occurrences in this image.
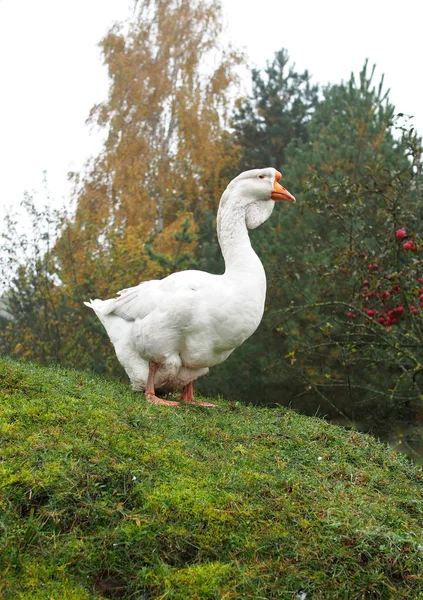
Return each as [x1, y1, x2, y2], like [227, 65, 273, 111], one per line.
[272, 113, 423, 430]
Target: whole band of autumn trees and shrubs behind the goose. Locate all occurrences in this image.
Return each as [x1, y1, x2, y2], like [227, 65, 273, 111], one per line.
[0, 0, 423, 458]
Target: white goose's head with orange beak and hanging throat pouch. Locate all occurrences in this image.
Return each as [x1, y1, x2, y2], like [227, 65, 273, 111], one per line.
[222, 167, 296, 229]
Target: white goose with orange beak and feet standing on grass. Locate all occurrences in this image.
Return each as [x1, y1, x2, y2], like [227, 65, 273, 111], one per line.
[85, 167, 295, 406]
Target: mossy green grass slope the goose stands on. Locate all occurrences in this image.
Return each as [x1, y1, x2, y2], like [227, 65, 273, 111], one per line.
[0, 359, 423, 600]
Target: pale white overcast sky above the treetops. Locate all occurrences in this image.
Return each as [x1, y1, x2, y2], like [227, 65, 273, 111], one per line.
[0, 0, 423, 219]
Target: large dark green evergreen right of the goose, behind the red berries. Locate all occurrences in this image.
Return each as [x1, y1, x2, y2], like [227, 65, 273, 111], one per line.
[203, 59, 423, 432]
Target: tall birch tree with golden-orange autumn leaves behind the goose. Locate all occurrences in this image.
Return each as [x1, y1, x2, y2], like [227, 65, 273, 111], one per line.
[62, 0, 239, 293]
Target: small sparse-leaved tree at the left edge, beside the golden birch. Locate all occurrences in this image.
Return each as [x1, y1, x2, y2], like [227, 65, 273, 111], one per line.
[0, 194, 78, 364]
